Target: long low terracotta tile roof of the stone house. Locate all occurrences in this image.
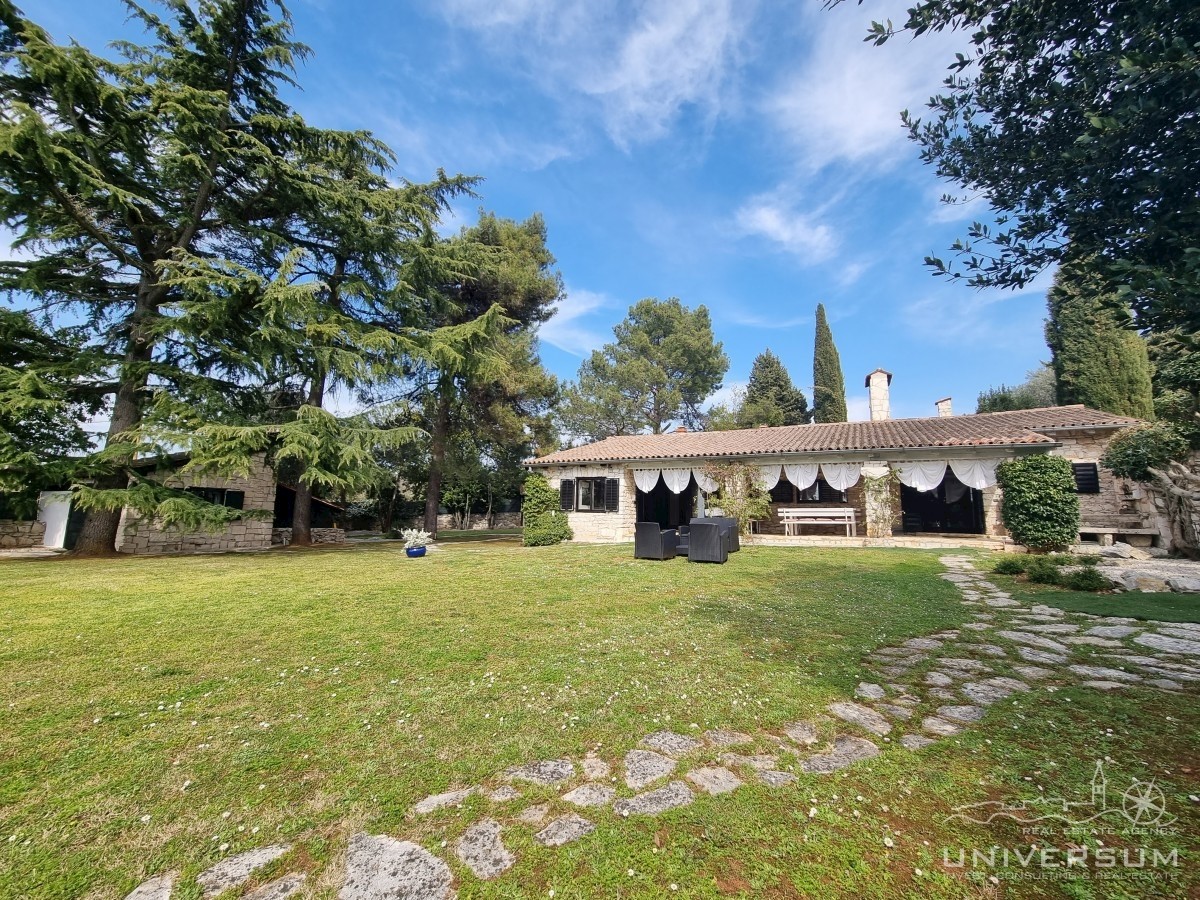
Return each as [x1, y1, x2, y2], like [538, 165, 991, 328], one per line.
[528, 406, 1139, 466]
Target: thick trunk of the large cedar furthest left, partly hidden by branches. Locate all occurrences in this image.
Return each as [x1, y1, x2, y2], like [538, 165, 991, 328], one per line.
[74, 281, 158, 557]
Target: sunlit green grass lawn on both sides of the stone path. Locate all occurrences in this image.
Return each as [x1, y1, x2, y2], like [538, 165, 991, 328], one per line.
[0, 542, 1200, 899]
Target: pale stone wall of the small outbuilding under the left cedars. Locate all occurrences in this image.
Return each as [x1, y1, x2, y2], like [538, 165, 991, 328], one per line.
[116, 457, 275, 553]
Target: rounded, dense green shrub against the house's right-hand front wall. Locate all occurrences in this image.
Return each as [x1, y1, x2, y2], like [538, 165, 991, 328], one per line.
[996, 455, 1079, 550]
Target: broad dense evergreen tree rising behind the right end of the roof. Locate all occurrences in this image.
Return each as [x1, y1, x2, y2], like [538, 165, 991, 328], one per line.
[1046, 259, 1154, 419]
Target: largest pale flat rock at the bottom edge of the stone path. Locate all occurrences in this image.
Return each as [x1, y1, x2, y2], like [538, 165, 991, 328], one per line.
[337, 832, 454, 900]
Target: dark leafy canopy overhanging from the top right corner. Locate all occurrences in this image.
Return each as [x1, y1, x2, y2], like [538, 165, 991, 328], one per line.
[864, 0, 1200, 331]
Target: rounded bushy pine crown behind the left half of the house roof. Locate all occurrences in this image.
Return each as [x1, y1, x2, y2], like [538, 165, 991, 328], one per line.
[562, 298, 730, 440]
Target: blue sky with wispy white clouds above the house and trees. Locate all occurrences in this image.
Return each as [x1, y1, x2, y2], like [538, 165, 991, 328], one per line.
[23, 0, 1049, 419]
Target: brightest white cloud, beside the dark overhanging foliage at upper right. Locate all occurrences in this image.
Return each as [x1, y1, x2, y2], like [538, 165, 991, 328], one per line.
[762, 4, 966, 170]
